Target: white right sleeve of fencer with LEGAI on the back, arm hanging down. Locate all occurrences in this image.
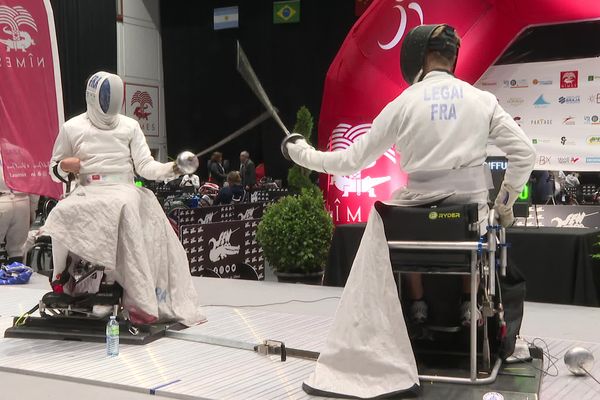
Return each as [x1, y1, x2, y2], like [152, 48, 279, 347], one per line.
[490, 99, 535, 193]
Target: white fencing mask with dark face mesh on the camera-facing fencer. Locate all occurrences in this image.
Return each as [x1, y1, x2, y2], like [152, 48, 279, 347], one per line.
[85, 71, 123, 129]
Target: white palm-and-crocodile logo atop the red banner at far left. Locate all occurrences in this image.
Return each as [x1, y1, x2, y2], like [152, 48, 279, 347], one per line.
[0, 6, 37, 52]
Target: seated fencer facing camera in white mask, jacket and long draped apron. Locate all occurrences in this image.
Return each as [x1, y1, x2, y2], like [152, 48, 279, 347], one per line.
[40, 72, 204, 325]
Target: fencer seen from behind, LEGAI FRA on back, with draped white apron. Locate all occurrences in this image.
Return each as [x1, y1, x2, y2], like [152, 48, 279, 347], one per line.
[282, 25, 535, 398]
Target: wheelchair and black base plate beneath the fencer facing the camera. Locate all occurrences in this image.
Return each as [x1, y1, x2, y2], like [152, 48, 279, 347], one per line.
[4, 206, 166, 344]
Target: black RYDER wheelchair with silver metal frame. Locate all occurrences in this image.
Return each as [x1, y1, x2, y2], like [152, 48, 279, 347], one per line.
[375, 202, 524, 384]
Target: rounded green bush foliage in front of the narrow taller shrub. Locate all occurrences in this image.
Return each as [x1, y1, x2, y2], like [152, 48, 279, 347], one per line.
[256, 185, 333, 285]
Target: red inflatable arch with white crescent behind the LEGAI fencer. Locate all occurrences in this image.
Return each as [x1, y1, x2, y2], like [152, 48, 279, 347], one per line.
[319, 0, 600, 224]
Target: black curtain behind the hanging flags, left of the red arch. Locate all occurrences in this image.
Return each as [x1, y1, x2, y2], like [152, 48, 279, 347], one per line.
[161, 0, 357, 178]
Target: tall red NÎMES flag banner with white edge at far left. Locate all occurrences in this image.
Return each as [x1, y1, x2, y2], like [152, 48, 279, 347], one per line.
[0, 0, 64, 197]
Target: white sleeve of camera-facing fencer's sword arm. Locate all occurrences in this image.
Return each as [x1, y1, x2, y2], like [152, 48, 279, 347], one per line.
[129, 124, 176, 181]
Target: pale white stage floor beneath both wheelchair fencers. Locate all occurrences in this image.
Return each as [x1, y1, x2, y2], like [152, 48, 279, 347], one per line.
[0, 276, 600, 400]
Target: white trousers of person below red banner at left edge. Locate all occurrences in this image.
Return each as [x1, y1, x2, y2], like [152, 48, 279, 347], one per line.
[0, 194, 31, 258]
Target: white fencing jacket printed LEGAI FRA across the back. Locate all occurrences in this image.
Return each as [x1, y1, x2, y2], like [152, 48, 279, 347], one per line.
[287, 71, 535, 225]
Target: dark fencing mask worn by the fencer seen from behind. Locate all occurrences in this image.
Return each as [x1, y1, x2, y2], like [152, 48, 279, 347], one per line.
[400, 24, 460, 85]
